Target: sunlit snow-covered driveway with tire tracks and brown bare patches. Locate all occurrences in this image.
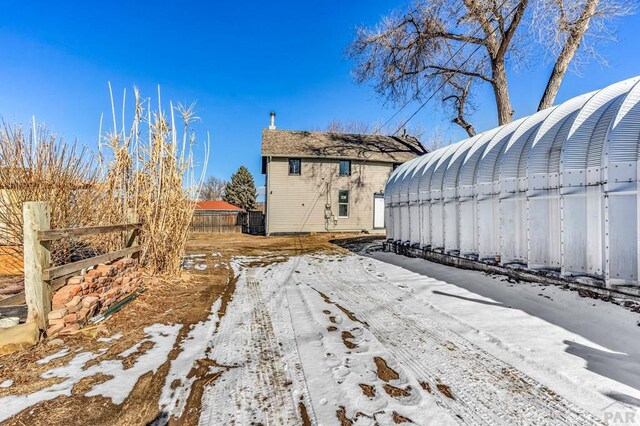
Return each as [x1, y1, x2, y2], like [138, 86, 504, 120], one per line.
[196, 251, 640, 425]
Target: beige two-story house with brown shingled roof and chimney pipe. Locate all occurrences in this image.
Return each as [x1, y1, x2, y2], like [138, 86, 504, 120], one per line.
[262, 123, 426, 235]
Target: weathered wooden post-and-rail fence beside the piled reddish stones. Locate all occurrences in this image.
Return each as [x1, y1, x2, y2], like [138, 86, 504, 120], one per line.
[23, 201, 140, 330]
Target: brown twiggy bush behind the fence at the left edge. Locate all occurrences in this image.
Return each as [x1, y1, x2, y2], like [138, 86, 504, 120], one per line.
[0, 124, 108, 264]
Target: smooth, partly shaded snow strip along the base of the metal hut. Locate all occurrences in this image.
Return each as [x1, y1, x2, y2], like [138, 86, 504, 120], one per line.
[372, 248, 640, 406]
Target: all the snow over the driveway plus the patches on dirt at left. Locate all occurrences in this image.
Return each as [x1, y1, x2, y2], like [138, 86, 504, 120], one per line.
[0, 246, 640, 425]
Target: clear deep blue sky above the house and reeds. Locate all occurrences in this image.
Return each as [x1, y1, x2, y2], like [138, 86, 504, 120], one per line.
[0, 0, 640, 185]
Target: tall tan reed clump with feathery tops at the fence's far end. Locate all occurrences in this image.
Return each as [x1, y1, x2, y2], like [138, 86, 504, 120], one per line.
[100, 86, 209, 274]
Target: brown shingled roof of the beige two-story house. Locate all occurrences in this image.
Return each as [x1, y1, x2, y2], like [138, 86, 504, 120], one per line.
[262, 129, 427, 163]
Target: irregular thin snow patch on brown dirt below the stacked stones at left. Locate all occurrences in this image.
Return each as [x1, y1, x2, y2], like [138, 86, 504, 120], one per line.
[0, 324, 180, 422]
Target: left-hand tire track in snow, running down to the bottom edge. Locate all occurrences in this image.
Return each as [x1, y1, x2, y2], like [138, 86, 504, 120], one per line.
[199, 264, 313, 425]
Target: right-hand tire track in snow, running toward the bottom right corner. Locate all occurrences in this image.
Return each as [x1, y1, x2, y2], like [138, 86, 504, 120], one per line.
[304, 256, 599, 425]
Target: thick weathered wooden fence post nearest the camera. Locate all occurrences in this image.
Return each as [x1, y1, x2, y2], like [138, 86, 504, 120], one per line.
[22, 201, 51, 330]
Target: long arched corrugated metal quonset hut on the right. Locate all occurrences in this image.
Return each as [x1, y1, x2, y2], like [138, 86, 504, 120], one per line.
[385, 77, 640, 286]
